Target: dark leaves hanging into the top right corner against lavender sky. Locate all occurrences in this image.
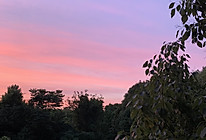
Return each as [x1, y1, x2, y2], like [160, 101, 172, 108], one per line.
[169, 0, 206, 48]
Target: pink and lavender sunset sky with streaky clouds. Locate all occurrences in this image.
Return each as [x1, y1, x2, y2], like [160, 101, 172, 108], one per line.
[0, 0, 206, 104]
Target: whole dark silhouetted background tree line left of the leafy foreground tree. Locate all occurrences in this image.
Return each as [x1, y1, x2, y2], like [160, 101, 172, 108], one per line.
[0, 85, 131, 140]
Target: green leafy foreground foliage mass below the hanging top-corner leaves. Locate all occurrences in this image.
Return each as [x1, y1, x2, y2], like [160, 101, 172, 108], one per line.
[127, 42, 206, 139]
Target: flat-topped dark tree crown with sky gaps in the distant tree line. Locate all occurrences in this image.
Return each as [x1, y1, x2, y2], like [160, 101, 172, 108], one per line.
[29, 89, 64, 109]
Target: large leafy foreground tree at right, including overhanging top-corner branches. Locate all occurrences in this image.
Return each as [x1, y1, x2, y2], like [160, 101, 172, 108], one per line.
[117, 0, 206, 139]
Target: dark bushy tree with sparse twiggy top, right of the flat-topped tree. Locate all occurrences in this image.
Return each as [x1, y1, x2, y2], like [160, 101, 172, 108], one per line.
[68, 90, 103, 135]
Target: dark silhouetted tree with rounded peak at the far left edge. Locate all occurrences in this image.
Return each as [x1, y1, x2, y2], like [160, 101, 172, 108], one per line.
[0, 85, 29, 139]
